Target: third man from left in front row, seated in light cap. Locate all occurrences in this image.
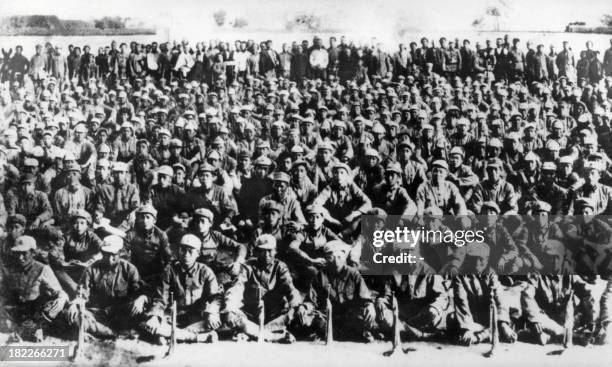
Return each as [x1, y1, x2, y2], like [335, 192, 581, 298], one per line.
[142, 234, 222, 343]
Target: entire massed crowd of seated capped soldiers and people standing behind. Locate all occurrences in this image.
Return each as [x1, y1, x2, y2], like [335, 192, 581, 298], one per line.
[0, 37, 612, 354]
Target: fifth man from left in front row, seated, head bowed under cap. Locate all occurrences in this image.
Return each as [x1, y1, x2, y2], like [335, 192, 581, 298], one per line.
[296, 240, 376, 342]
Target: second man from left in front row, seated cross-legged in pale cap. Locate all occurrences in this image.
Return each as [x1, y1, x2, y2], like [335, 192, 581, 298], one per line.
[66, 235, 149, 339]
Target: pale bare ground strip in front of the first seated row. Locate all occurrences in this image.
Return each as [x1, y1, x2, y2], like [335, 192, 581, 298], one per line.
[0, 335, 612, 367]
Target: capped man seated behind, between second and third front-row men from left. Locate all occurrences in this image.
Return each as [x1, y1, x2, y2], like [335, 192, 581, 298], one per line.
[122, 204, 173, 284]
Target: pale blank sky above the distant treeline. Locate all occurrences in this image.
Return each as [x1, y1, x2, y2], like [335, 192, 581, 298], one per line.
[0, 0, 612, 31]
